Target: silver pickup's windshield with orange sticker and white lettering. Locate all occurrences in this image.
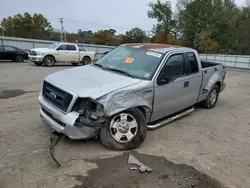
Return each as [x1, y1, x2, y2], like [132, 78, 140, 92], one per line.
[96, 46, 163, 80]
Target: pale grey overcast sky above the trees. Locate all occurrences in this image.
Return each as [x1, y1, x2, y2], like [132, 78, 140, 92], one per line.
[0, 0, 245, 33]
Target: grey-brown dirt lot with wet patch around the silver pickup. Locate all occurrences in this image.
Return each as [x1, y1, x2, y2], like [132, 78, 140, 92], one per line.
[0, 62, 250, 188]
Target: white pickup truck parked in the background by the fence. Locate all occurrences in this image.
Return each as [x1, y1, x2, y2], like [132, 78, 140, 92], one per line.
[29, 42, 95, 67]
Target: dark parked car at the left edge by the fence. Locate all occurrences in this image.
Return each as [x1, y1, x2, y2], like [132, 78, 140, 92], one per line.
[0, 45, 29, 62]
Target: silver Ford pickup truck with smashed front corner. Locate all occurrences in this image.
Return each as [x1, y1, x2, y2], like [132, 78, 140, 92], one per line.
[39, 43, 226, 150]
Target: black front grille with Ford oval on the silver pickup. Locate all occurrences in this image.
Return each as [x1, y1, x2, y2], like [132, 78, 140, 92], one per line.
[43, 82, 73, 112]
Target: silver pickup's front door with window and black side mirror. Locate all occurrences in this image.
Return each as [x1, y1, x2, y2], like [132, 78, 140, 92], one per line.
[151, 53, 189, 121]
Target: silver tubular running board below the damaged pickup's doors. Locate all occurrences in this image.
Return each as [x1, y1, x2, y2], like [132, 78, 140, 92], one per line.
[148, 106, 194, 130]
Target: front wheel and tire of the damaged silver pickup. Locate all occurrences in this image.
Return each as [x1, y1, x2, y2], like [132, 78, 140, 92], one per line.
[100, 108, 147, 151]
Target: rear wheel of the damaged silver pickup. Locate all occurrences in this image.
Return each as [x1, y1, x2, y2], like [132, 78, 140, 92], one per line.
[201, 84, 219, 109]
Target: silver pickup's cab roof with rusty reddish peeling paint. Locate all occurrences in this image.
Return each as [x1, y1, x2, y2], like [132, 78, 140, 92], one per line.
[121, 43, 194, 53]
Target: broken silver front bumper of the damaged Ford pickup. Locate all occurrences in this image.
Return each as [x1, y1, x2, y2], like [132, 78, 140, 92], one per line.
[38, 93, 98, 139]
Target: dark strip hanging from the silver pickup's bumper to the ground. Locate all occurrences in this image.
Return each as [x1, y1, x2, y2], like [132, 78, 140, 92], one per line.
[49, 131, 63, 167]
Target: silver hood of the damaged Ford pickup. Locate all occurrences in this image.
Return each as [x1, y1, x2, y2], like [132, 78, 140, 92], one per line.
[45, 65, 141, 99]
